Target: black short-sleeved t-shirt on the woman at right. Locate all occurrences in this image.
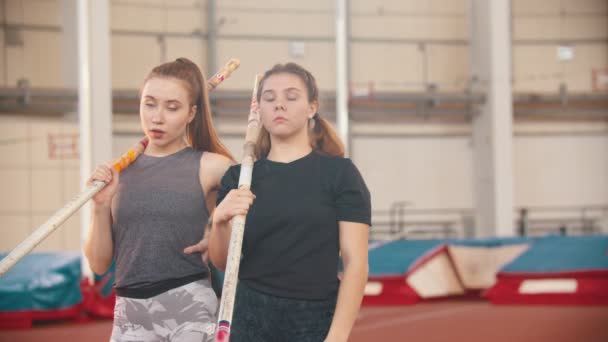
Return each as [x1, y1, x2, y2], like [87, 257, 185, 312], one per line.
[217, 151, 371, 300]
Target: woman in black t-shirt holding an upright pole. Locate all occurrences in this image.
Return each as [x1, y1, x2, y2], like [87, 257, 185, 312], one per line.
[209, 63, 371, 342]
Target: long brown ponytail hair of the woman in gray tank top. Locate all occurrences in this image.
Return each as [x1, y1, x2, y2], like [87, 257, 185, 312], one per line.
[144, 57, 234, 160]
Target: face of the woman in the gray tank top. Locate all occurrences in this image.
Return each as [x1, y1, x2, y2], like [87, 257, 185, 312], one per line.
[139, 77, 196, 152]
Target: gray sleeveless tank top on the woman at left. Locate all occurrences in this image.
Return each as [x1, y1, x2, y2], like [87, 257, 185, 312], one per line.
[112, 147, 209, 288]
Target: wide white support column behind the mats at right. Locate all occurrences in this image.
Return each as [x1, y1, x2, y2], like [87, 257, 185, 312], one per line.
[470, 0, 515, 237]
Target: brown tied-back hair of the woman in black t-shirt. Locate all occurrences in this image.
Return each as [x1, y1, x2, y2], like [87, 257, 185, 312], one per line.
[255, 63, 344, 159]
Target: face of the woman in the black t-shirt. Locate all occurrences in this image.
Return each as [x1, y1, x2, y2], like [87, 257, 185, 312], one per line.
[259, 73, 317, 139]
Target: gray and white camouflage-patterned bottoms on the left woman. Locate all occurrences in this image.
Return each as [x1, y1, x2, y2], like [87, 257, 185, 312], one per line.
[110, 279, 218, 342]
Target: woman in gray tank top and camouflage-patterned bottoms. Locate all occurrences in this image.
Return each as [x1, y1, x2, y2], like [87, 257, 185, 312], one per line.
[84, 58, 233, 341]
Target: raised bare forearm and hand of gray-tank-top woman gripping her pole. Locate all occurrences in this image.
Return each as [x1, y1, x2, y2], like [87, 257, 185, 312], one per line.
[84, 165, 119, 274]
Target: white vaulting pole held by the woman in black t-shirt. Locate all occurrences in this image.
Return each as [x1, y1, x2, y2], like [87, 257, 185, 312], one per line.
[215, 75, 261, 342]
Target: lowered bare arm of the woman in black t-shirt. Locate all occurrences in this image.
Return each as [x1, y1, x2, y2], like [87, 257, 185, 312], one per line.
[325, 221, 369, 342]
